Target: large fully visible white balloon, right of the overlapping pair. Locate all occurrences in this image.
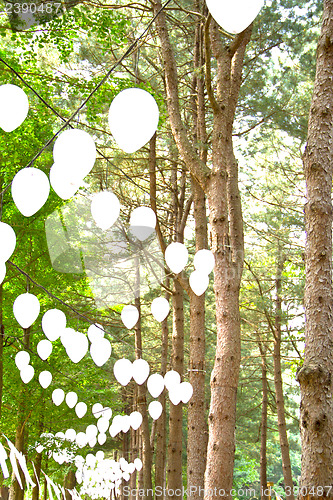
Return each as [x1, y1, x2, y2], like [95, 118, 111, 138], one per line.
[109, 88, 159, 153]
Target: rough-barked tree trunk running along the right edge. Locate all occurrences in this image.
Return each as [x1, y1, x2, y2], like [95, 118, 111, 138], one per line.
[298, 0, 333, 498]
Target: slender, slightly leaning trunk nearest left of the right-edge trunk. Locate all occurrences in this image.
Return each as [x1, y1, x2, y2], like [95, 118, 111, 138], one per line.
[273, 256, 294, 500]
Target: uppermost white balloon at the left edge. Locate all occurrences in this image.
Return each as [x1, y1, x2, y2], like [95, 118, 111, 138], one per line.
[0, 83, 29, 132]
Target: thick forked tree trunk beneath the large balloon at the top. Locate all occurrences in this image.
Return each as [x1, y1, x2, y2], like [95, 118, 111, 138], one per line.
[154, 0, 252, 500]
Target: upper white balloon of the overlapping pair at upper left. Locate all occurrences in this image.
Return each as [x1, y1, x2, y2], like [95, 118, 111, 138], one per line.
[53, 129, 96, 174]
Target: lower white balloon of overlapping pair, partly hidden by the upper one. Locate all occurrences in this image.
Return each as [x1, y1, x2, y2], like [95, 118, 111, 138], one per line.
[50, 163, 83, 200]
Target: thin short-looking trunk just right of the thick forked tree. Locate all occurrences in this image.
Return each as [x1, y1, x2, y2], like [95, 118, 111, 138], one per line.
[258, 340, 268, 500]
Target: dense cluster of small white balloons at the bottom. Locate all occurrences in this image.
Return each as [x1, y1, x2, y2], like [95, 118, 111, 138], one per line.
[75, 451, 142, 499]
